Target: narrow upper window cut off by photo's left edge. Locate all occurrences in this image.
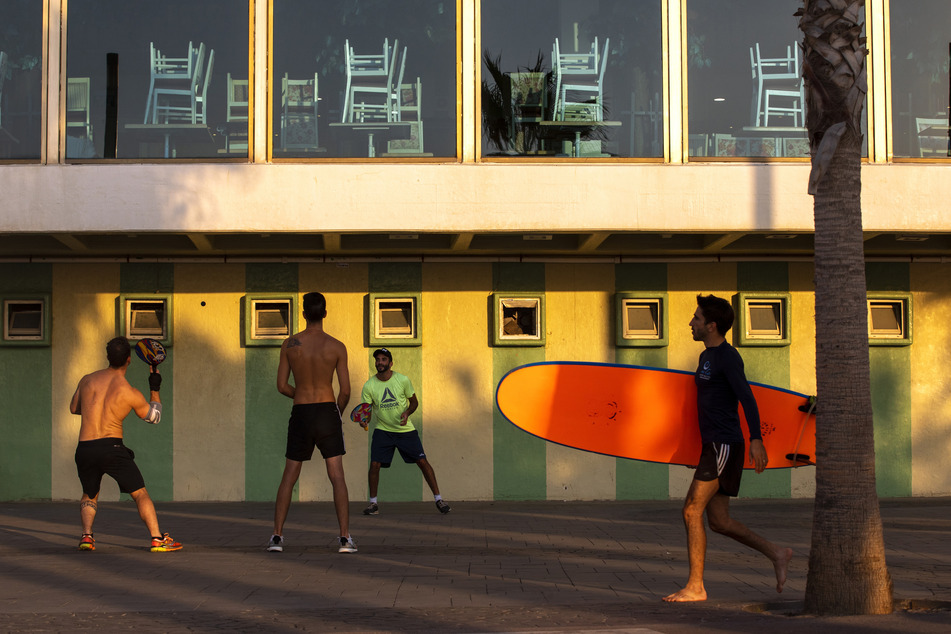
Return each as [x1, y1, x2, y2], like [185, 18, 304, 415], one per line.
[0, 0, 43, 160]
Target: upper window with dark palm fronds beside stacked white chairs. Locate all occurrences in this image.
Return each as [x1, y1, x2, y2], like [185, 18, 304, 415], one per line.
[481, 0, 664, 158]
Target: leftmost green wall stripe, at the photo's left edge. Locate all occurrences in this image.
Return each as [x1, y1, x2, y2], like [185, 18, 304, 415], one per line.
[0, 264, 52, 500]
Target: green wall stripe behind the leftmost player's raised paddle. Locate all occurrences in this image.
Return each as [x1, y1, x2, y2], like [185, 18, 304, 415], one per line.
[120, 262, 175, 501]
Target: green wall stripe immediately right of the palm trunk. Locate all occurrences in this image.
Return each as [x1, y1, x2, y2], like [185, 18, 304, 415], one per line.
[865, 262, 914, 497]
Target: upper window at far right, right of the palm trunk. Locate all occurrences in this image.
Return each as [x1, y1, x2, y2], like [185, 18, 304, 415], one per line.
[889, 0, 951, 160]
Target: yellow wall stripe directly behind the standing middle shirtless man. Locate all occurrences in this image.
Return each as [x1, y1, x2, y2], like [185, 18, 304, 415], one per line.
[300, 263, 370, 501]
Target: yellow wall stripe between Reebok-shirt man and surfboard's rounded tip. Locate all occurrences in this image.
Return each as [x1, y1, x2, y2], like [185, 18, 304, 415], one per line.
[421, 263, 495, 500]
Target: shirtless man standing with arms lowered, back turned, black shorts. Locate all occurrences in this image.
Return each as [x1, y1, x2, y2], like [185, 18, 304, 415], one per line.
[267, 293, 357, 553]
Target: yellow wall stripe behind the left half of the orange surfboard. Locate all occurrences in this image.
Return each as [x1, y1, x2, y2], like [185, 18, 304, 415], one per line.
[545, 263, 617, 500]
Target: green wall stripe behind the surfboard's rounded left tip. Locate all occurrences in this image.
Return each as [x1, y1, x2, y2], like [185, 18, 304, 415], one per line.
[487, 262, 548, 500]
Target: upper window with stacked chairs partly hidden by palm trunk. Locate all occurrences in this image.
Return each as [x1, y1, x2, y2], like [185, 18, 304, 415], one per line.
[685, 0, 868, 158]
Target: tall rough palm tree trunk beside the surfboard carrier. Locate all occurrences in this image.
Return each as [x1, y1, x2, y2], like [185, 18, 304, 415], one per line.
[797, 0, 892, 615]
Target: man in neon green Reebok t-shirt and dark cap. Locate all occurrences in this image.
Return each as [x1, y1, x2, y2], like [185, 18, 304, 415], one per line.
[360, 348, 450, 515]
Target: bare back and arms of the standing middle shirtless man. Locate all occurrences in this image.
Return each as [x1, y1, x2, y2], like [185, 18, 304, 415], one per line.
[277, 323, 350, 410]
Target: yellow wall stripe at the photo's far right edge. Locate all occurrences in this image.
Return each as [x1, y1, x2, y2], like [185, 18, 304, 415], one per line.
[911, 264, 951, 495]
